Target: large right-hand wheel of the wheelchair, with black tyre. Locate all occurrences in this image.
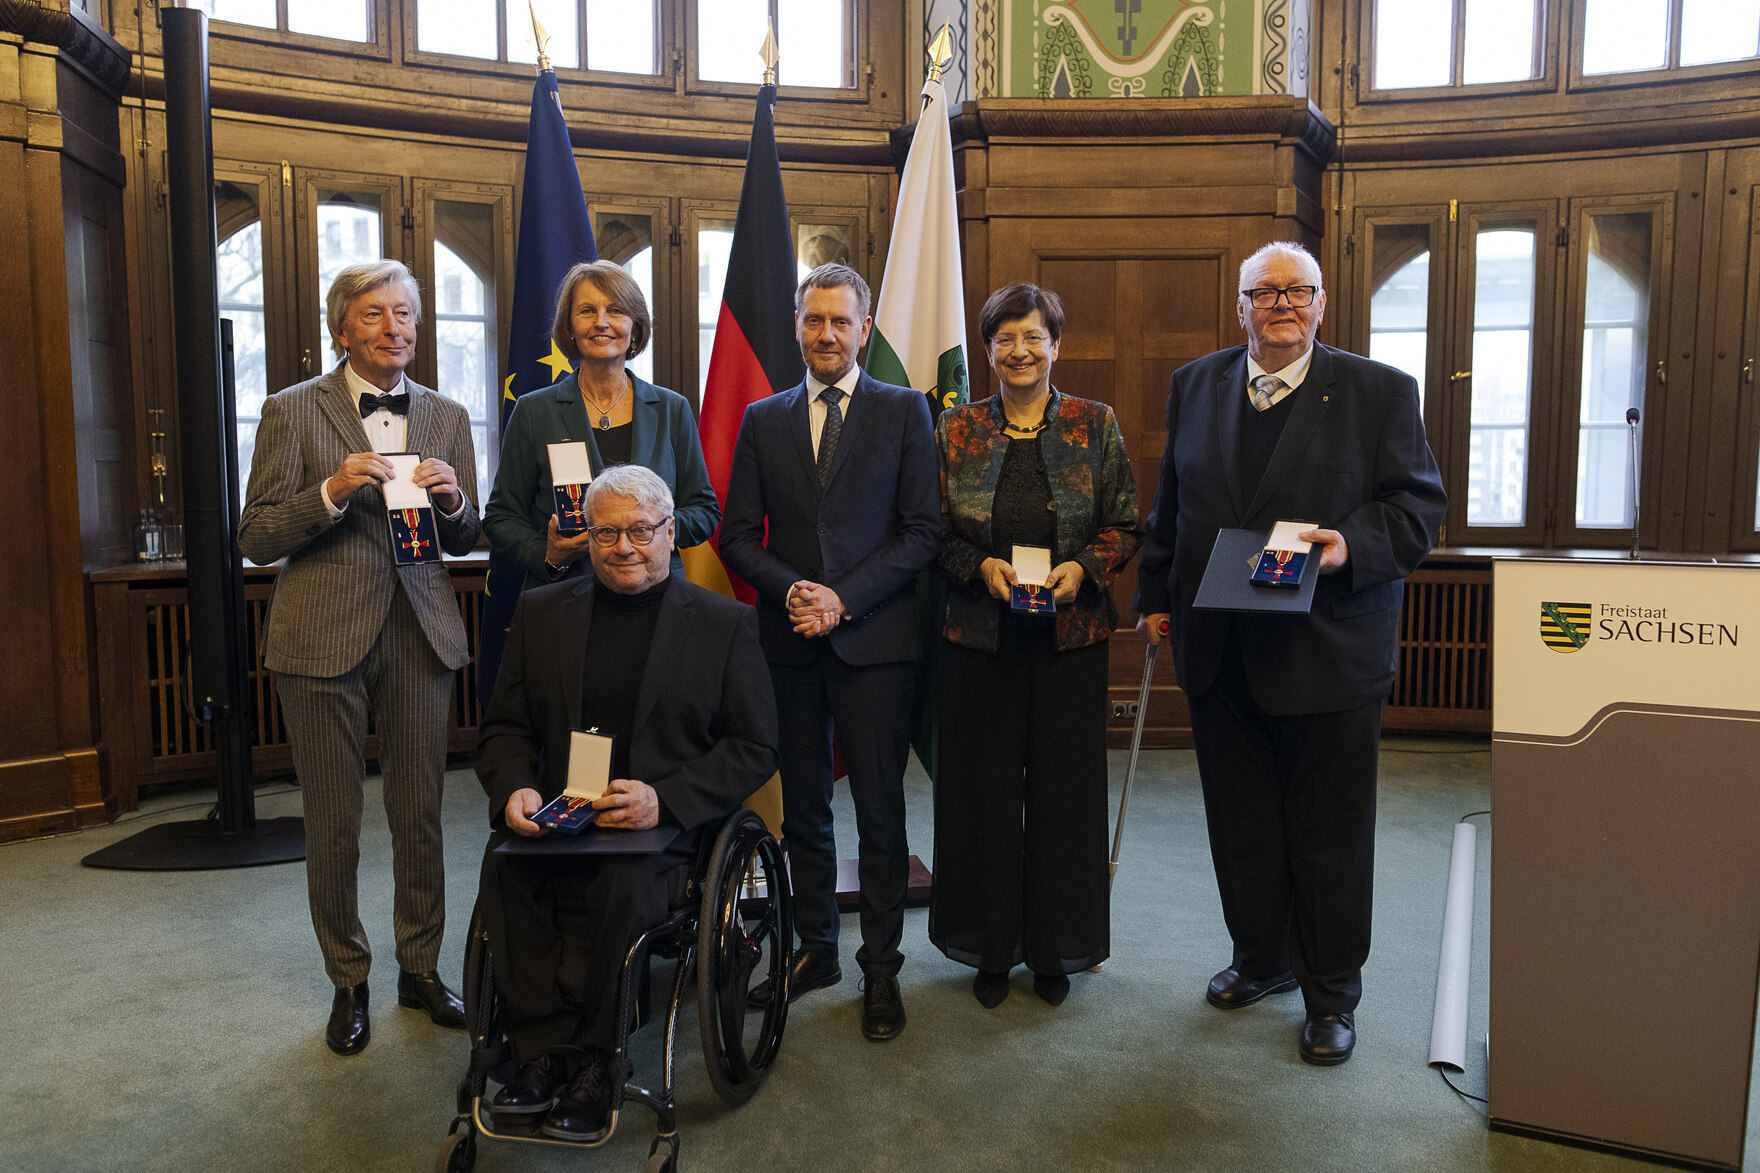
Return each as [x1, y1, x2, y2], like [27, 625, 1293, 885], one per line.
[697, 810, 794, 1108]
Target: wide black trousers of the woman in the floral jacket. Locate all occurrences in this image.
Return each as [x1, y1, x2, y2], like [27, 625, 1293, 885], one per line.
[929, 618, 1111, 974]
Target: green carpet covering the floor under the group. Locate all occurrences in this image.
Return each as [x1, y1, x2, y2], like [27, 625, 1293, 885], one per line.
[0, 738, 1760, 1173]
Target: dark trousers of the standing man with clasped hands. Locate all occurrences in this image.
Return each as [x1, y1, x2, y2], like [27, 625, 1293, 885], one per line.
[771, 641, 917, 974]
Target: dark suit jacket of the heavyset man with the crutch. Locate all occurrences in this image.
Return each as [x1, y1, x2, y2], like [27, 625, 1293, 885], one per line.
[1137, 343, 1448, 713]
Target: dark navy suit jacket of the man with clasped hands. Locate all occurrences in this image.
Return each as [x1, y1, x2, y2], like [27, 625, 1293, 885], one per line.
[722, 372, 942, 666]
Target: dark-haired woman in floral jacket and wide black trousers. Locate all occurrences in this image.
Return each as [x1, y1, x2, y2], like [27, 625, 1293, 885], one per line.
[929, 284, 1142, 1007]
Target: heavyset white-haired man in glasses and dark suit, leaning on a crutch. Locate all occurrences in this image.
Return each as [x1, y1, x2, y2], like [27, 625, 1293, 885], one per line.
[1137, 243, 1447, 1066]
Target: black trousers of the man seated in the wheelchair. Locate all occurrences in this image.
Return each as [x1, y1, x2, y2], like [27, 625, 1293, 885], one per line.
[480, 831, 699, 1064]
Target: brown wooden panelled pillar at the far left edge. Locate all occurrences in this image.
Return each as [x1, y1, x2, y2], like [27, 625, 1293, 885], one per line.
[0, 22, 136, 838]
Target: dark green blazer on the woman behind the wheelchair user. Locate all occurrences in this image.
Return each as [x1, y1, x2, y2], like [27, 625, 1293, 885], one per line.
[482, 373, 722, 588]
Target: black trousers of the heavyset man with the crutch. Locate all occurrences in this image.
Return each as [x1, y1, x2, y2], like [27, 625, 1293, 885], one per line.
[1188, 619, 1382, 1014]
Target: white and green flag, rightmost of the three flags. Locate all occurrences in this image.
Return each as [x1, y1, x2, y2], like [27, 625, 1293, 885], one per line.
[868, 79, 970, 416]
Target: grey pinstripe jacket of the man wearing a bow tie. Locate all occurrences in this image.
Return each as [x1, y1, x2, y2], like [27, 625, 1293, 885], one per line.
[238, 366, 482, 676]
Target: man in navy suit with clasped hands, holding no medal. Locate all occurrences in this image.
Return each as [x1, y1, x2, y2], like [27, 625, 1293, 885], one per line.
[722, 264, 942, 1041]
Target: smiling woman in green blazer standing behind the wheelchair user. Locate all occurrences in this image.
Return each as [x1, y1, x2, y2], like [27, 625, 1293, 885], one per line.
[482, 261, 722, 588]
